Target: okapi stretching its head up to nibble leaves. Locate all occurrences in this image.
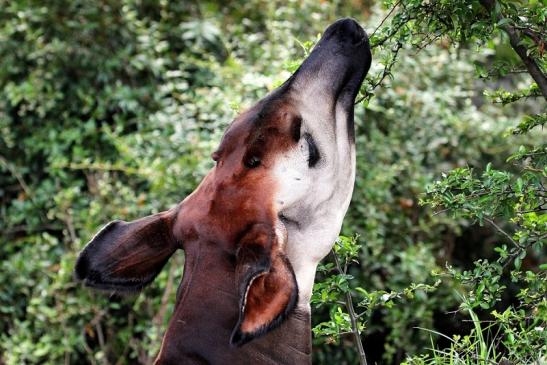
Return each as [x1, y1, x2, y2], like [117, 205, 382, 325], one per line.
[75, 19, 371, 365]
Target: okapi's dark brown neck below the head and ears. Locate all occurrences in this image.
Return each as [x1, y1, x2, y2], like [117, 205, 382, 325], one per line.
[155, 240, 311, 365]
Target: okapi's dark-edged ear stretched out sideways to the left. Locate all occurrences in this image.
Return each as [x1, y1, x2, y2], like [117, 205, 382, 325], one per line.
[74, 211, 180, 291]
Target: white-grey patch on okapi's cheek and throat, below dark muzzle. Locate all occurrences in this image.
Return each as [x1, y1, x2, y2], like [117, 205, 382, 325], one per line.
[274, 100, 355, 308]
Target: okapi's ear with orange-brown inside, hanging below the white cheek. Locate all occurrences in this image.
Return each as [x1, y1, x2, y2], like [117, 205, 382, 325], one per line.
[230, 224, 298, 346]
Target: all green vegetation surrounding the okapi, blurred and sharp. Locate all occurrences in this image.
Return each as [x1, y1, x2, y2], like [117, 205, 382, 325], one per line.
[0, 0, 547, 364]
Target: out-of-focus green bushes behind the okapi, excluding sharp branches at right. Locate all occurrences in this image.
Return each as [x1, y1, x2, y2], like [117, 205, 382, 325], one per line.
[0, 0, 545, 364]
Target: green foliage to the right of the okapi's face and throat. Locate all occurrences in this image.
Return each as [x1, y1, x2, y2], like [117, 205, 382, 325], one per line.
[308, 1, 547, 364]
